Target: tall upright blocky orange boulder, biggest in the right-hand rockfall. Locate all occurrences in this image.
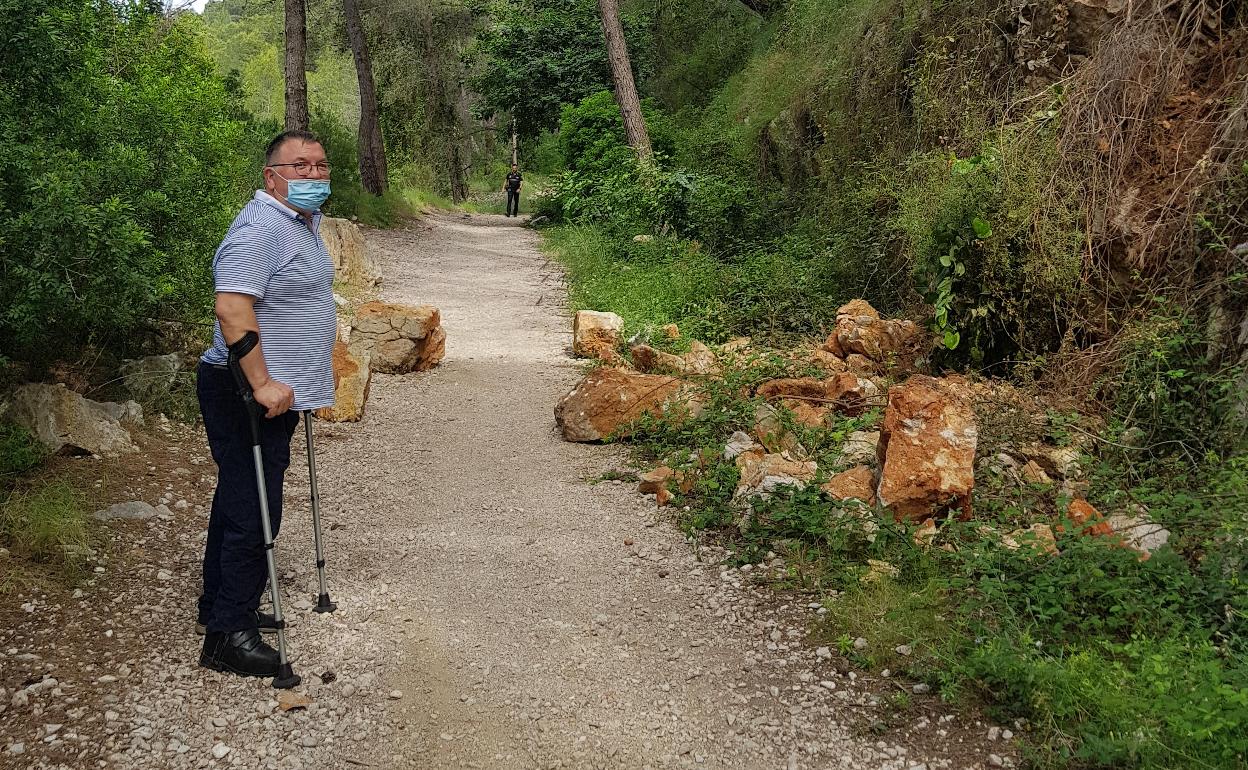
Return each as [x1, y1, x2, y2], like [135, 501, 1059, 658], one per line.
[877, 374, 978, 520]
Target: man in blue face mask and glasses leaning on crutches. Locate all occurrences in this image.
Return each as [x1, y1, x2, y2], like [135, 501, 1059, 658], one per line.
[198, 131, 337, 676]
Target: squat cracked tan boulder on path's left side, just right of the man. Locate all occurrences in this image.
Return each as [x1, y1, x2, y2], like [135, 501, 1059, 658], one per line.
[349, 302, 447, 374]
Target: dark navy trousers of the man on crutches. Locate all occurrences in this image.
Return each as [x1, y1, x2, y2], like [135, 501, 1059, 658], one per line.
[198, 362, 300, 631]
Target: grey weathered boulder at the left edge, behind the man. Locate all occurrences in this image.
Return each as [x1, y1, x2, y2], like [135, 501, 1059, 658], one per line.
[0, 383, 144, 454]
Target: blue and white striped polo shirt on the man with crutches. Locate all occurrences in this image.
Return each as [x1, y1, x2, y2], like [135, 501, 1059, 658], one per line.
[203, 190, 338, 411]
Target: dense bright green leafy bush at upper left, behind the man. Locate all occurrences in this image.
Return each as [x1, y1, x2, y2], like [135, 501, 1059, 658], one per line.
[0, 0, 245, 354]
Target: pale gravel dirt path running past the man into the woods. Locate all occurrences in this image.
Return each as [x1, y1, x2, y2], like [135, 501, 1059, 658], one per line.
[0, 215, 1010, 770]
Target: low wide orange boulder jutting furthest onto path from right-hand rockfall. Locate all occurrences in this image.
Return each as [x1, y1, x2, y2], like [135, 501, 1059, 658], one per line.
[554, 367, 701, 442]
